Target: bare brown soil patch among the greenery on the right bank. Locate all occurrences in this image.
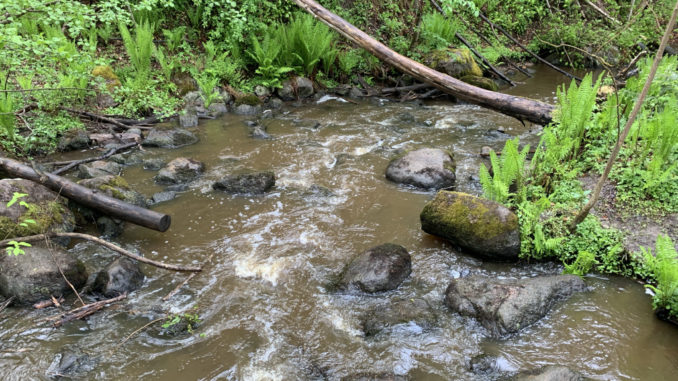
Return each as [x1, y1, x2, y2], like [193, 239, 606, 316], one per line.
[579, 175, 678, 252]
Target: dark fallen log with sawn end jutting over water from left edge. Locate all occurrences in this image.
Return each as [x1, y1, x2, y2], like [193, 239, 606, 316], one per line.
[0, 157, 171, 232]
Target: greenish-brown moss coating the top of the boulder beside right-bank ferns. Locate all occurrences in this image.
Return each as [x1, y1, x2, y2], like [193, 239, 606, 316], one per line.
[421, 191, 518, 239]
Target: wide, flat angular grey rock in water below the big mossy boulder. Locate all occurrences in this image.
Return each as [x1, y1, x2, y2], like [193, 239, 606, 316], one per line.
[445, 275, 586, 336]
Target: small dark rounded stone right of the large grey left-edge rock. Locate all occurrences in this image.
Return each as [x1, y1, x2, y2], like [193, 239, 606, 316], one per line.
[92, 257, 145, 298]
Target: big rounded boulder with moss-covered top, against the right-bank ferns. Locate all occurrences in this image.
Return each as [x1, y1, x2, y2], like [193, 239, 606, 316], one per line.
[420, 191, 520, 261]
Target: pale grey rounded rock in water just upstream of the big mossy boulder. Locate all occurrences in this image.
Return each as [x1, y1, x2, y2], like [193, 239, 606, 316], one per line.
[386, 148, 456, 189]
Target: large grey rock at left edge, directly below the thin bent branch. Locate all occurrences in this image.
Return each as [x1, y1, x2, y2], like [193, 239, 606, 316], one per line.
[0, 244, 87, 304]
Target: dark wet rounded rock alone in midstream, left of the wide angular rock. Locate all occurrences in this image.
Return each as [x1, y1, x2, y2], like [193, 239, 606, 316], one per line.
[340, 243, 412, 292]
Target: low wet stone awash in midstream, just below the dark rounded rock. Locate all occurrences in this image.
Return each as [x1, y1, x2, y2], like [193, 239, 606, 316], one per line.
[360, 298, 438, 337]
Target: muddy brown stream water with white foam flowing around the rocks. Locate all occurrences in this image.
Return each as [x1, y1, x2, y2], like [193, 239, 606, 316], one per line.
[0, 70, 678, 380]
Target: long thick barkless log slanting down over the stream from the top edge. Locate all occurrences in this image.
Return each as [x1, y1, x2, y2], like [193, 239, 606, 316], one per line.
[294, 0, 555, 124]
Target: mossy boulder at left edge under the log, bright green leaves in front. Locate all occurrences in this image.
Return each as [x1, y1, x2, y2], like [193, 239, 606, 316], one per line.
[0, 179, 75, 239]
